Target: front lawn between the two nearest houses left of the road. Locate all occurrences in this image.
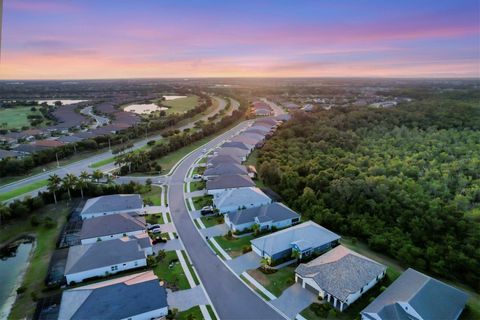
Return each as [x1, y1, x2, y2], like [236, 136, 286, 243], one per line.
[153, 251, 190, 290]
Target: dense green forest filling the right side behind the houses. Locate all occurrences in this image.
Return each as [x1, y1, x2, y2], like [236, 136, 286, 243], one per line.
[259, 92, 480, 290]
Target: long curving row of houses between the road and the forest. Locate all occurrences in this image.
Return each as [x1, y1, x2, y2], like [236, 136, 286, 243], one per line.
[198, 118, 468, 320]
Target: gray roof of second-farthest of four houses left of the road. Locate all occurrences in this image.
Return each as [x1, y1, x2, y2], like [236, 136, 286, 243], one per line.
[80, 213, 145, 239]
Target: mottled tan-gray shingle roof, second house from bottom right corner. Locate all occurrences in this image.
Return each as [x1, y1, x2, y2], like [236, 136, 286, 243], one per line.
[295, 249, 386, 301]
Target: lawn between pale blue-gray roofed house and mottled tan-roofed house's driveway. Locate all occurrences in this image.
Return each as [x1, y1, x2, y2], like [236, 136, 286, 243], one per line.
[247, 266, 295, 297]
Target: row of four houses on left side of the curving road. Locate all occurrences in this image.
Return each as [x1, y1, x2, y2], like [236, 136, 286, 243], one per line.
[59, 194, 168, 320]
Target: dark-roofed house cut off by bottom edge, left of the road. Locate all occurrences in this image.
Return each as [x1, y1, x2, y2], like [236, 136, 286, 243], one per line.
[58, 271, 168, 320]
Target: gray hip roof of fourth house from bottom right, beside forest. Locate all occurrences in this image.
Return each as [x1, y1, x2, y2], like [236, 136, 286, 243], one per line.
[228, 202, 300, 225]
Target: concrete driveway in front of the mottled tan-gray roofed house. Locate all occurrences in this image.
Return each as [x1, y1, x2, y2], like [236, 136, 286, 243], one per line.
[270, 283, 317, 319]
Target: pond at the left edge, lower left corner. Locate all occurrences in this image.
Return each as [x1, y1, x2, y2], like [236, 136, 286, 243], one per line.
[0, 239, 33, 319]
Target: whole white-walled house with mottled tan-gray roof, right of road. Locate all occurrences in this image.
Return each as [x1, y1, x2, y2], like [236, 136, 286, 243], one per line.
[295, 246, 387, 311]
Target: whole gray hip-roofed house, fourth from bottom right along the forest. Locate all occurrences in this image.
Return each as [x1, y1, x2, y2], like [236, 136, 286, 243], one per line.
[225, 202, 300, 231]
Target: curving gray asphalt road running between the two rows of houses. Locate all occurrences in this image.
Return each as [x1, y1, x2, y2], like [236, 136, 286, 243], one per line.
[168, 121, 284, 319]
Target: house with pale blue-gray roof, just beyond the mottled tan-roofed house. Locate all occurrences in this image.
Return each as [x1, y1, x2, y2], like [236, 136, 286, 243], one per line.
[250, 221, 340, 261]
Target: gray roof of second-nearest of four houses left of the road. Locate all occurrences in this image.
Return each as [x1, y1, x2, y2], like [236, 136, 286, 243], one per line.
[65, 239, 145, 274]
